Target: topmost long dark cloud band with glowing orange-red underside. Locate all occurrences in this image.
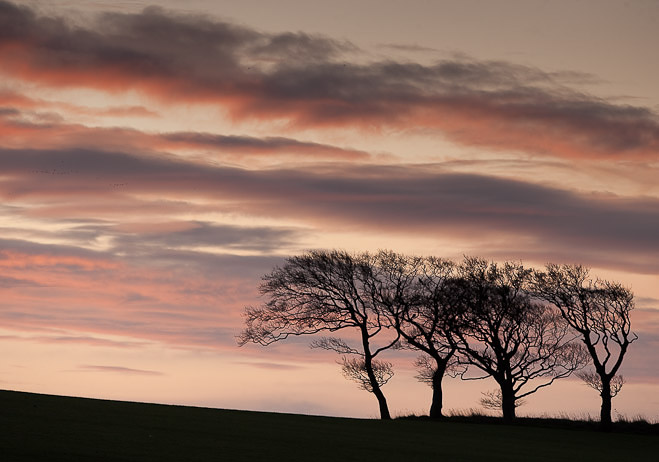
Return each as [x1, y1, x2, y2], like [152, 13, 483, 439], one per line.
[0, 2, 659, 160]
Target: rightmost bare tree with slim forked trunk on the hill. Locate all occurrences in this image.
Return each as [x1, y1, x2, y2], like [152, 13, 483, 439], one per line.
[534, 264, 638, 429]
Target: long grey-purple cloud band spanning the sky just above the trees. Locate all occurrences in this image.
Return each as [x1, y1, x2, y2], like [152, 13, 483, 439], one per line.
[0, 144, 659, 272]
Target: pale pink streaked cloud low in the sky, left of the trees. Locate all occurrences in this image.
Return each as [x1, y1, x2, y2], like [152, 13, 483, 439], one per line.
[0, 233, 281, 350]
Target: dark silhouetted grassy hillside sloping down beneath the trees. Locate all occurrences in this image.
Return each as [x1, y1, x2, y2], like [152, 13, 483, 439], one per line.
[0, 391, 659, 462]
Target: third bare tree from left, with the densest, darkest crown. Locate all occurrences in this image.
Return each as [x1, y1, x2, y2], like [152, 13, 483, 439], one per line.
[450, 258, 584, 421]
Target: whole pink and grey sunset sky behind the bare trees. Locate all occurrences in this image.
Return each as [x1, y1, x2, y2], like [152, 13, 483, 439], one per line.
[0, 0, 659, 420]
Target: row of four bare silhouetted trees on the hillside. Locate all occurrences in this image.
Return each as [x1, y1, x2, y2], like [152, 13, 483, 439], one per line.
[238, 250, 638, 426]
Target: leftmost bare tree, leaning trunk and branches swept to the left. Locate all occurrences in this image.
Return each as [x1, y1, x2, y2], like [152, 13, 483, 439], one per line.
[238, 250, 398, 419]
